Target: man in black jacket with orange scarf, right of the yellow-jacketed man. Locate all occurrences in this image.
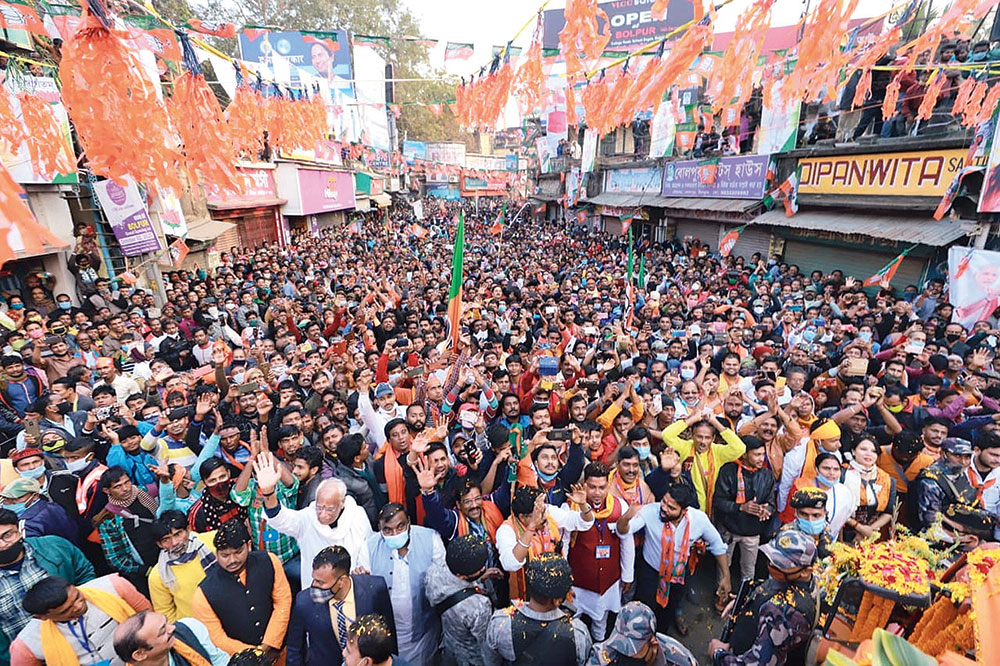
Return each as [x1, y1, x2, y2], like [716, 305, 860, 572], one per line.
[714, 436, 774, 580]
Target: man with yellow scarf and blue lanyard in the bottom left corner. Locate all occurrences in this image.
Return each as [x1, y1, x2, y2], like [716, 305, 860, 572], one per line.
[10, 574, 150, 666]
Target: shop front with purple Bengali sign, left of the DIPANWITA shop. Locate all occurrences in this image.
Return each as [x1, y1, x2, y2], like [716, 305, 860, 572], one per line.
[658, 155, 771, 258]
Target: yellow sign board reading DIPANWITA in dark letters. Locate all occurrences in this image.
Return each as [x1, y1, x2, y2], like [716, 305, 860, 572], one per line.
[799, 149, 980, 197]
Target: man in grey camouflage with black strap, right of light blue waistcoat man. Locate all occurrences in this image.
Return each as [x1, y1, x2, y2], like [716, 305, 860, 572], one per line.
[424, 534, 499, 666]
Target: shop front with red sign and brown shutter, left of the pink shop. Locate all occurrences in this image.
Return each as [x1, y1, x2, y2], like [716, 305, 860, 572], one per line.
[205, 164, 287, 250]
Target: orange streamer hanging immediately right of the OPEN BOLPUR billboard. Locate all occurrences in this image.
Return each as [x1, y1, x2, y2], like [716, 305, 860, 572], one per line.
[709, 0, 775, 113]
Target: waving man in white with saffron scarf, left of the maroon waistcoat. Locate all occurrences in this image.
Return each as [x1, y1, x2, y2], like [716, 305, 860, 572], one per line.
[496, 485, 594, 600]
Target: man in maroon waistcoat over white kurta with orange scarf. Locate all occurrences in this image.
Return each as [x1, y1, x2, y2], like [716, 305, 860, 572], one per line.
[568, 462, 635, 641]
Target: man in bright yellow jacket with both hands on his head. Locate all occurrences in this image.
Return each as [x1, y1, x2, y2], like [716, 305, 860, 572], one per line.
[662, 407, 746, 515]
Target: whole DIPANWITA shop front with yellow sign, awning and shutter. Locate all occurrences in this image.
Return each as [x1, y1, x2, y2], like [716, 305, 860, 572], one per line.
[754, 144, 981, 280]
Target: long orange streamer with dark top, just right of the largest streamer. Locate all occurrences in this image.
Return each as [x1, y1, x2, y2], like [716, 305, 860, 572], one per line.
[168, 30, 241, 192]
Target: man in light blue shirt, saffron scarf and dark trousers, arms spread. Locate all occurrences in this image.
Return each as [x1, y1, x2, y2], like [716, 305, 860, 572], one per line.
[616, 480, 743, 636]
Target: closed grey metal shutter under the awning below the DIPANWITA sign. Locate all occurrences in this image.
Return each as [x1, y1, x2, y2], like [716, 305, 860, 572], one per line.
[784, 239, 927, 290]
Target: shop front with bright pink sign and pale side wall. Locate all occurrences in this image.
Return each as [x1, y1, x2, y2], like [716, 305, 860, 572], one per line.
[274, 161, 356, 231]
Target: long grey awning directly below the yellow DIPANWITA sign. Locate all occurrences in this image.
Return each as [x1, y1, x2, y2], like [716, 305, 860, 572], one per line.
[753, 208, 969, 247]
